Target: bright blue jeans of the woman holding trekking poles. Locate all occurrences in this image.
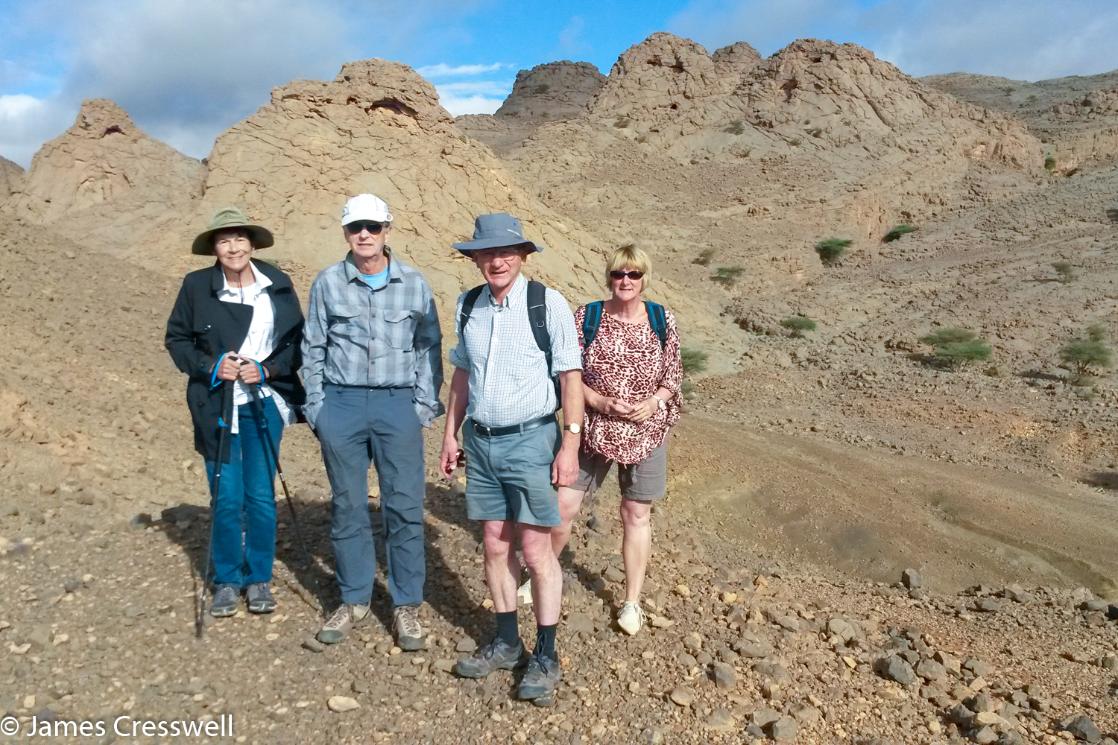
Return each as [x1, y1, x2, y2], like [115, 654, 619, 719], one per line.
[206, 398, 283, 587]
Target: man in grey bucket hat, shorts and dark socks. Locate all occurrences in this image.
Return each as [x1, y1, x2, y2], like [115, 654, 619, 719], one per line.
[440, 213, 582, 706]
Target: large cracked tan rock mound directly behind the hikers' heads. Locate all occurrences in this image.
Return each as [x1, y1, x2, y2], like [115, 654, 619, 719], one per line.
[200, 59, 621, 302]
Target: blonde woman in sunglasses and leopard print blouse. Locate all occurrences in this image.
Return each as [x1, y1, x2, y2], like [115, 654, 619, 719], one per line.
[552, 245, 683, 634]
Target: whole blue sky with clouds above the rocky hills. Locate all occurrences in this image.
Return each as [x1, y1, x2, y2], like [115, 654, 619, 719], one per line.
[0, 0, 1118, 166]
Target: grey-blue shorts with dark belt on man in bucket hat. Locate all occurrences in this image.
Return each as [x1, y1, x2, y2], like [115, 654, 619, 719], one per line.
[462, 422, 560, 528]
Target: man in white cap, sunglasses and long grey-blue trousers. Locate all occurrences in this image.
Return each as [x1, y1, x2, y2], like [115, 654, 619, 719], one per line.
[300, 194, 444, 651]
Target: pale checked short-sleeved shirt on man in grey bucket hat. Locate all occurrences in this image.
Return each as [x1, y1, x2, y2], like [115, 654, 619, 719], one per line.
[451, 275, 582, 427]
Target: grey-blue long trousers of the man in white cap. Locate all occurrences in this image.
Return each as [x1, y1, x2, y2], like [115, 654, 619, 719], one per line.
[315, 385, 427, 605]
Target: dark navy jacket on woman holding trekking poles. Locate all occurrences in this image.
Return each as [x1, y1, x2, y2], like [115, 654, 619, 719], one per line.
[163, 260, 305, 461]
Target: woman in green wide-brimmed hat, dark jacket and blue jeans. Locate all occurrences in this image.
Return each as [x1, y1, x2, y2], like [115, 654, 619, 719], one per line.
[164, 207, 304, 617]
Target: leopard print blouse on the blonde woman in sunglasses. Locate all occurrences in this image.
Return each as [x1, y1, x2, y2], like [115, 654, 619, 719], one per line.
[575, 305, 683, 464]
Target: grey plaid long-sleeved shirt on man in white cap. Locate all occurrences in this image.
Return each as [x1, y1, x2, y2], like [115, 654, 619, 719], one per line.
[300, 248, 445, 427]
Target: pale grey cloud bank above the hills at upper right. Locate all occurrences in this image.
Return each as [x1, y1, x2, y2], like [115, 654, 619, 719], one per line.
[669, 0, 1118, 79]
